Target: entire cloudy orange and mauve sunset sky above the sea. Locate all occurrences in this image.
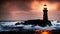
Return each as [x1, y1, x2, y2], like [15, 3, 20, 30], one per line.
[0, 0, 60, 20]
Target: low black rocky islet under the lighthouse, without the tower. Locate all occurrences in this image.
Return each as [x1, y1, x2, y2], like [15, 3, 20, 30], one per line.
[20, 19, 51, 27]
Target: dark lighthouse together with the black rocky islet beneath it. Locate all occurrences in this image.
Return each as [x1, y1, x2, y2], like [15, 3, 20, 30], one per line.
[24, 4, 51, 27]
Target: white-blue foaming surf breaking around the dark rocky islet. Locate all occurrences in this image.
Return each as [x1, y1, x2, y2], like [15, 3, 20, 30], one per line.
[0, 21, 60, 31]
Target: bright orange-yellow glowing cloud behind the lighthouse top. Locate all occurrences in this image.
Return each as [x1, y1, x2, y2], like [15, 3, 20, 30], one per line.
[31, 1, 58, 12]
